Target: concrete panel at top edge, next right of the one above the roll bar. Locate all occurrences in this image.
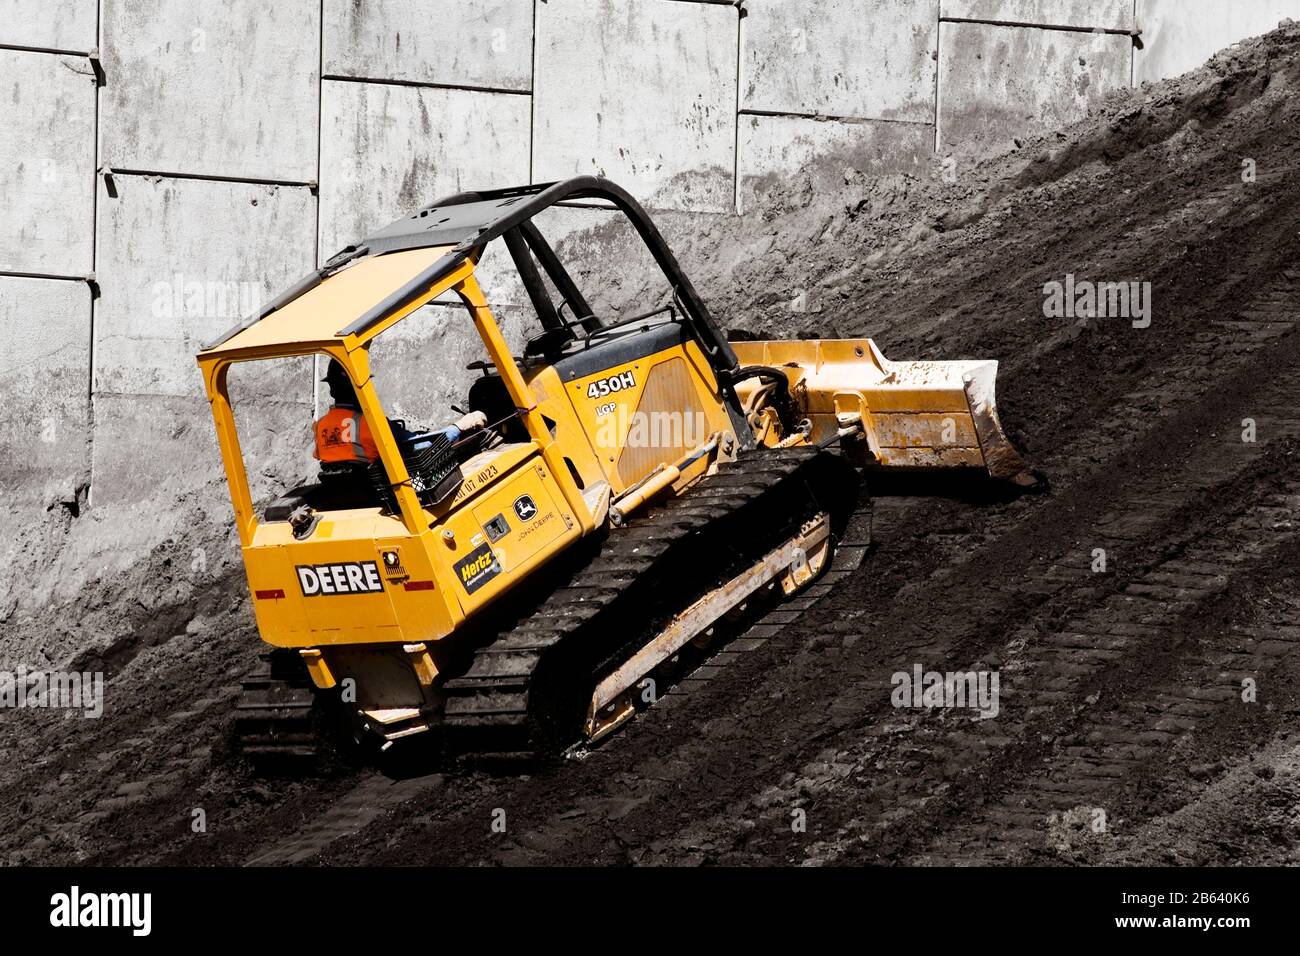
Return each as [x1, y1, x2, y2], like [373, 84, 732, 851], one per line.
[741, 0, 939, 122]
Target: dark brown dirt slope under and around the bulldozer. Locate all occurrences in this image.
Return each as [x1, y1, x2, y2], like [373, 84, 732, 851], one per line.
[0, 27, 1300, 865]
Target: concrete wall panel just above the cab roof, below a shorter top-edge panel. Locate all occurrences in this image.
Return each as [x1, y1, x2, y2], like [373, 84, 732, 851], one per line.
[320, 81, 530, 302]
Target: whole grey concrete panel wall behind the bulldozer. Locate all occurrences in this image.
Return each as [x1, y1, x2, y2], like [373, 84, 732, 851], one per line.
[0, 0, 1300, 505]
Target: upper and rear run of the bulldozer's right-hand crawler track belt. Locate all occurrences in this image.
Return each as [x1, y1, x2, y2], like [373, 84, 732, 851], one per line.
[445, 449, 859, 757]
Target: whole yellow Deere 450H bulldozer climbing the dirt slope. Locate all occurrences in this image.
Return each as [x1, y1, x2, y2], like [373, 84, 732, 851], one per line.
[198, 177, 1036, 761]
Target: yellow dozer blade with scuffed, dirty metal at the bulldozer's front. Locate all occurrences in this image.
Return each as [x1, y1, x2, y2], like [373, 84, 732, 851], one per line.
[732, 338, 1039, 486]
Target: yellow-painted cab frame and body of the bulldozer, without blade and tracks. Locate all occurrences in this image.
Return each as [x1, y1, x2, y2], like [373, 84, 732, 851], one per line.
[199, 254, 731, 687]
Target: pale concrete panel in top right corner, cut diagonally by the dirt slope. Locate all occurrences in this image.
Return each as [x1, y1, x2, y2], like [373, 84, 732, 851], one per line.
[1135, 0, 1300, 83]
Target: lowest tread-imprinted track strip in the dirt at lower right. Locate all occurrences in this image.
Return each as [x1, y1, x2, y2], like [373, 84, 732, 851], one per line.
[930, 515, 1300, 864]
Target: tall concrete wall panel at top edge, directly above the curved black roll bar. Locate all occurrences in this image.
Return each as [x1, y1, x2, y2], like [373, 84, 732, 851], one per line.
[533, 0, 736, 212]
